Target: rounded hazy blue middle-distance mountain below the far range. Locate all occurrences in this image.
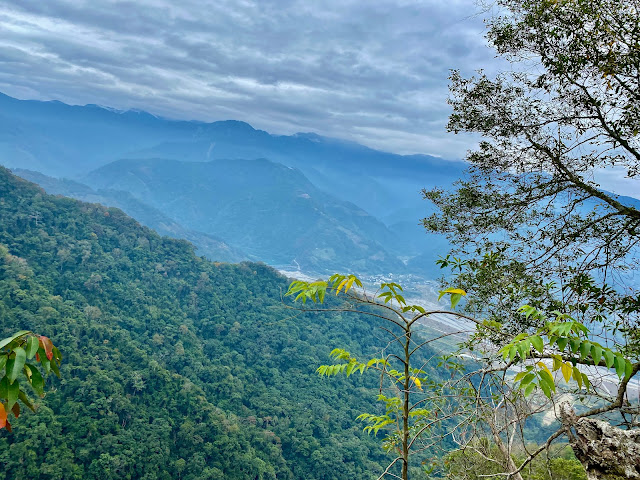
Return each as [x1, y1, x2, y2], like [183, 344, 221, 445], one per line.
[85, 159, 404, 272]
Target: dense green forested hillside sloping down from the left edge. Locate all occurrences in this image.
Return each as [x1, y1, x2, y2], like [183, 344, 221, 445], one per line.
[0, 168, 408, 480]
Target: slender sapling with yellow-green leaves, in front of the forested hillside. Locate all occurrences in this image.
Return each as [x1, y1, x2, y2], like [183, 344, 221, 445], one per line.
[286, 274, 484, 480]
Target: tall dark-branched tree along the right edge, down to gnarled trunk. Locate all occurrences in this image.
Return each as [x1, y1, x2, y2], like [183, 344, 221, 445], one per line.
[424, 0, 640, 478]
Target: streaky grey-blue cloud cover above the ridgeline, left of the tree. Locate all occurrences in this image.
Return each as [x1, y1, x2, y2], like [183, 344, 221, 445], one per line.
[0, 0, 496, 158]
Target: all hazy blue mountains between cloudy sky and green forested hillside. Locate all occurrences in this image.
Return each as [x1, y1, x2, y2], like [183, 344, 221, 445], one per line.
[0, 95, 463, 277]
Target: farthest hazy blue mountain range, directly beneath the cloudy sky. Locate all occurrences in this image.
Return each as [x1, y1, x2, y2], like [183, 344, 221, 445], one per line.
[0, 94, 464, 220]
